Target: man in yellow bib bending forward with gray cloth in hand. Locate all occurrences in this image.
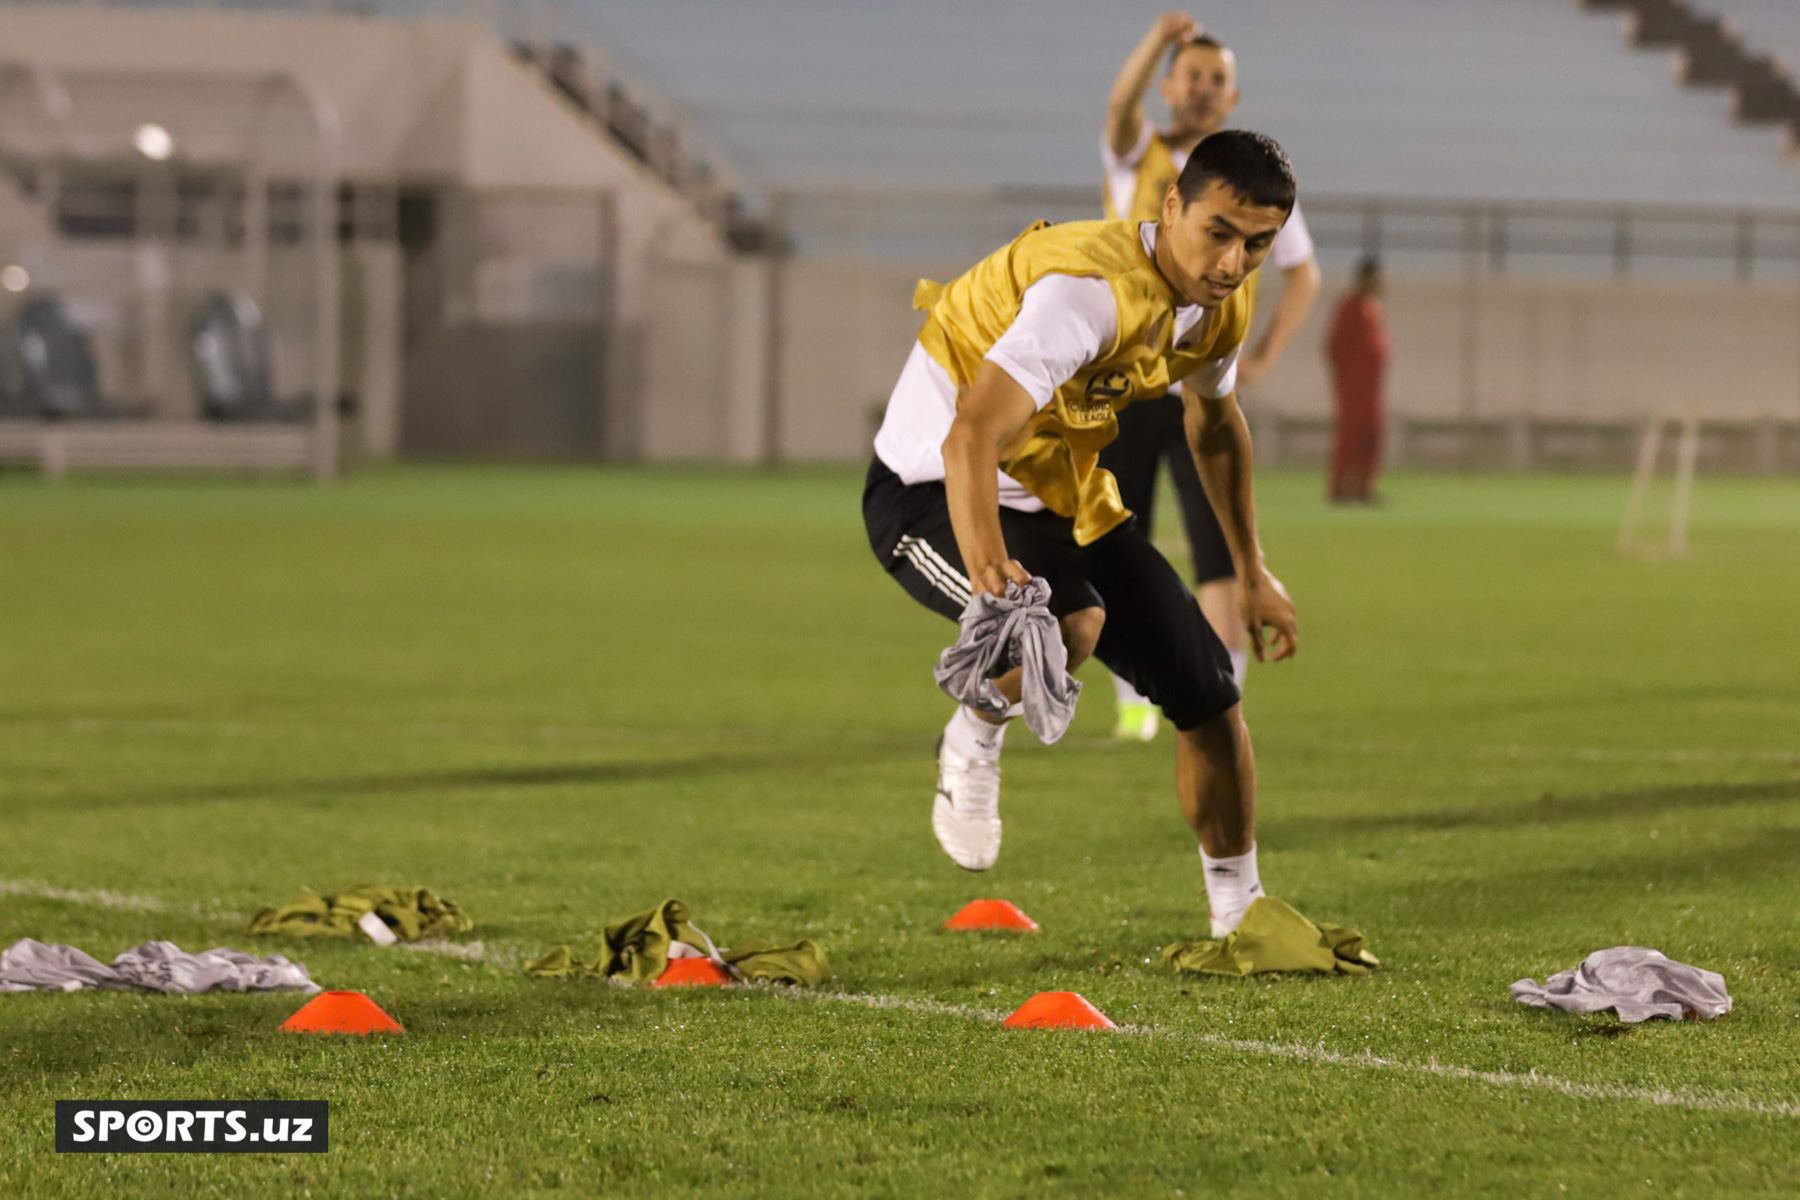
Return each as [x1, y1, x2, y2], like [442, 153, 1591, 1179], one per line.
[862, 131, 1300, 936]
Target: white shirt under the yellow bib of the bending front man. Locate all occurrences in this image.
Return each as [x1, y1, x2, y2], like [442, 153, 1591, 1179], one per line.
[875, 221, 1238, 513]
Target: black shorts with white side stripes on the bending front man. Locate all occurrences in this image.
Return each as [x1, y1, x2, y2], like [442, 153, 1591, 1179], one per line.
[862, 459, 1238, 729]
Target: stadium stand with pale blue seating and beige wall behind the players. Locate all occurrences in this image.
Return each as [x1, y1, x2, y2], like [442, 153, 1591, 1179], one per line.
[598, 0, 1800, 470]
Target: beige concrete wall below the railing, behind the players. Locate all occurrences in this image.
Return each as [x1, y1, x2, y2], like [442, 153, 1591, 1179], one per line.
[669, 259, 1800, 461]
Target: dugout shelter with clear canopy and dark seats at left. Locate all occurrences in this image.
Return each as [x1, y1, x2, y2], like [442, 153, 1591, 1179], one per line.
[0, 59, 340, 477]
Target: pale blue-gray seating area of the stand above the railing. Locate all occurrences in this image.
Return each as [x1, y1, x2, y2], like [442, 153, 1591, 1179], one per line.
[587, 0, 1800, 209]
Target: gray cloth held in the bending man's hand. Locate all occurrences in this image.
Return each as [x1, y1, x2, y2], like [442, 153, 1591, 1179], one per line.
[934, 576, 1082, 743]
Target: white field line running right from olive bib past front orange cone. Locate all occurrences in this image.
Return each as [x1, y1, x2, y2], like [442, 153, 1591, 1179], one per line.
[784, 988, 1800, 1117]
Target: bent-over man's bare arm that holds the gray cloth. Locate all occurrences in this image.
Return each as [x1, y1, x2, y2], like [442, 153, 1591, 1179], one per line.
[943, 362, 1037, 596]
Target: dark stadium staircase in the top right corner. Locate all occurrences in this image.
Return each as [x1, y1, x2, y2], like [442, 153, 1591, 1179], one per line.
[1579, 0, 1800, 155]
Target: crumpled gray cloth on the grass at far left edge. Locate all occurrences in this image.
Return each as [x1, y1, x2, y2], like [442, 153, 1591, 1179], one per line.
[0, 937, 319, 991]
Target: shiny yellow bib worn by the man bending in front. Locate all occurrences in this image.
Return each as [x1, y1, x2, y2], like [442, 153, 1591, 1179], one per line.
[913, 221, 1256, 545]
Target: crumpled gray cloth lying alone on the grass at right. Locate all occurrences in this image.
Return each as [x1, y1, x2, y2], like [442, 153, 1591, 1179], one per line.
[1512, 946, 1732, 1024]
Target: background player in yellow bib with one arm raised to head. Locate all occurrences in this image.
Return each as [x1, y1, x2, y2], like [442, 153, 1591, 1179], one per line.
[1100, 13, 1319, 741]
